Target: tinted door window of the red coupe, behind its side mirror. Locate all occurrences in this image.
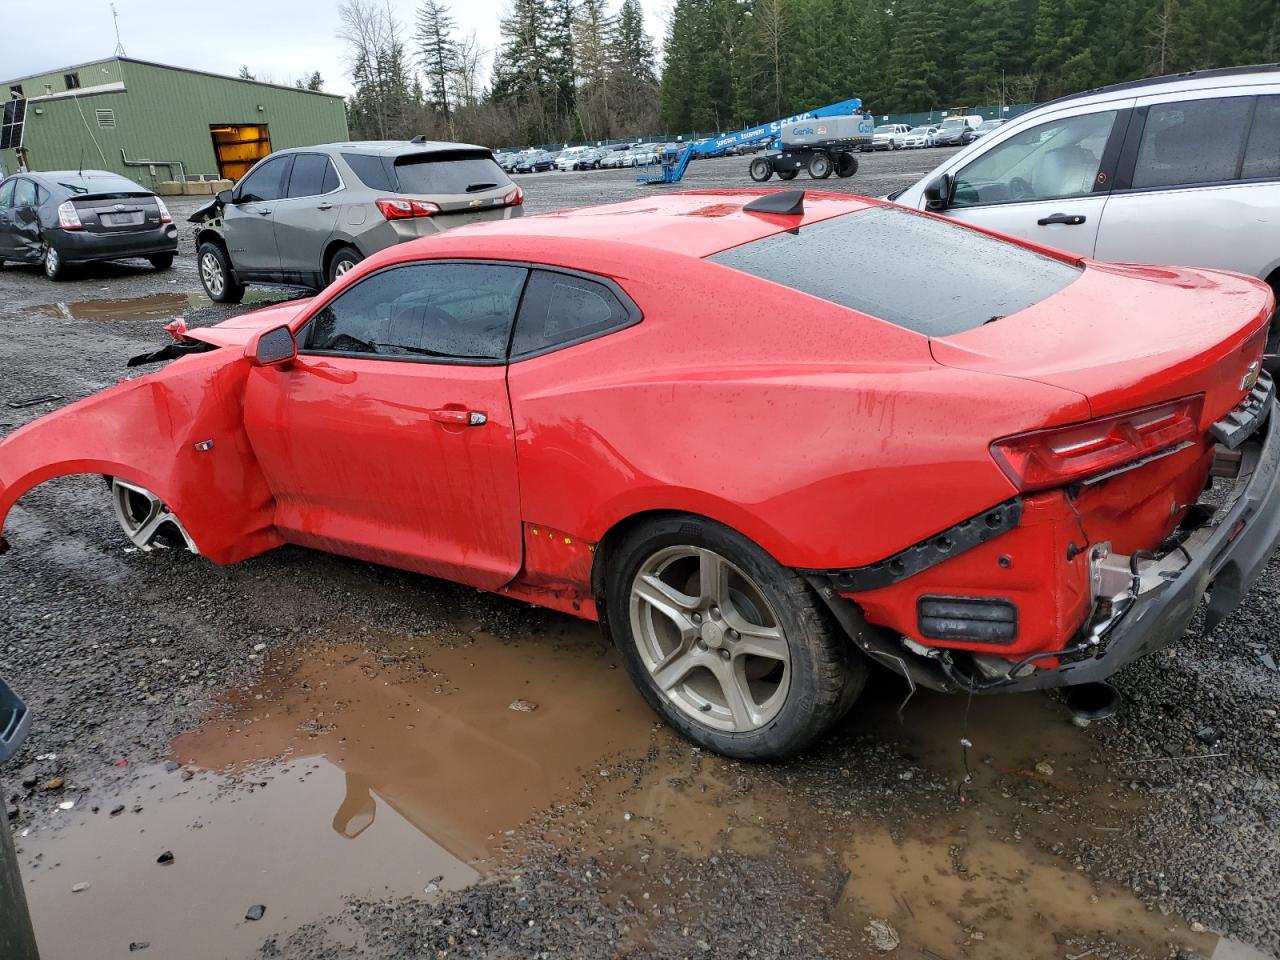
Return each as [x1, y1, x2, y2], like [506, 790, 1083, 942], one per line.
[306, 264, 529, 360]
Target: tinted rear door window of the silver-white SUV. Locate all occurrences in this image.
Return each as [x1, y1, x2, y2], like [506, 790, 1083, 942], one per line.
[1133, 97, 1253, 189]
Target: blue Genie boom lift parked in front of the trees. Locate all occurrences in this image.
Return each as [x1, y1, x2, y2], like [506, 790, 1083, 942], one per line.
[636, 97, 876, 183]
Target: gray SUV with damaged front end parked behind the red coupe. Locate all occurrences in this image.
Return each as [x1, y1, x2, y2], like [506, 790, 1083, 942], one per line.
[189, 141, 525, 303]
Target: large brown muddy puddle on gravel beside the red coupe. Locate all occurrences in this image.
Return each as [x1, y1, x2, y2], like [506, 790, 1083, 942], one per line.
[18, 620, 1252, 960]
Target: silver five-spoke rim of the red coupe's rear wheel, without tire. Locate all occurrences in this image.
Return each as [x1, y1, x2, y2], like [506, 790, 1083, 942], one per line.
[630, 545, 791, 733]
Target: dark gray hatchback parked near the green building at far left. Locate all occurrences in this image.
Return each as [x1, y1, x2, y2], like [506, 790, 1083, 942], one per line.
[0, 170, 178, 280]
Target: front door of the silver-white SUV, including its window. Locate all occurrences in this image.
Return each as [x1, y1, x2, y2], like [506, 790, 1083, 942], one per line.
[945, 105, 1129, 257]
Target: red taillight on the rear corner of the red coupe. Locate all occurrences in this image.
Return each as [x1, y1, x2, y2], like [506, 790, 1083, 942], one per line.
[991, 394, 1204, 492]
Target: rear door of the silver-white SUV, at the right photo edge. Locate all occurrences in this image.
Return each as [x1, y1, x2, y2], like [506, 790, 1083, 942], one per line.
[1097, 84, 1280, 276]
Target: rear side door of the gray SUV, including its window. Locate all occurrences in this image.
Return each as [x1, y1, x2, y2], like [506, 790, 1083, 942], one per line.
[273, 154, 342, 285]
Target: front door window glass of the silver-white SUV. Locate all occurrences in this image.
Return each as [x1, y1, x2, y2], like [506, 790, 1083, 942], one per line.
[951, 110, 1116, 207]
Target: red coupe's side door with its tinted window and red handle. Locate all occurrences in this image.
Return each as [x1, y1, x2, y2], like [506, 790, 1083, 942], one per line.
[244, 261, 527, 590]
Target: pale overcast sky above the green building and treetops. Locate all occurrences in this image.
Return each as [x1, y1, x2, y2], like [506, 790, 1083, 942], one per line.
[0, 0, 671, 93]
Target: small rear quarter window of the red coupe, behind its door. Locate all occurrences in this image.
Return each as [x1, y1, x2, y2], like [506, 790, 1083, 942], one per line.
[511, 270, 634, 357]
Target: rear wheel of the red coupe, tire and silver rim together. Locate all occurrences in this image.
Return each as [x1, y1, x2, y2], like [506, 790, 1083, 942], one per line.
[605, 516, 867, 760]
